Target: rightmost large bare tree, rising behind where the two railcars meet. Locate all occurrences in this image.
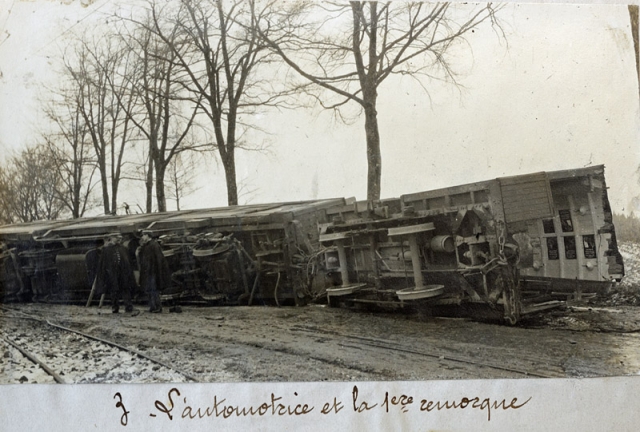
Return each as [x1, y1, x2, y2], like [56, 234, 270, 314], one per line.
[259, 1, 500, 200]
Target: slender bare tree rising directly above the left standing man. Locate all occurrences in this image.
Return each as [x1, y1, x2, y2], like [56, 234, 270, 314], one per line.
[64, 34, 136, 214]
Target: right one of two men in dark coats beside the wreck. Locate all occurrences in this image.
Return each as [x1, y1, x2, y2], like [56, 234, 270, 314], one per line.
[138, 231, 171, 313]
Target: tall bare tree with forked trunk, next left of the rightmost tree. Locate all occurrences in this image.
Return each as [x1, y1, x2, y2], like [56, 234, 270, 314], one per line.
[139, 0, 296, 205]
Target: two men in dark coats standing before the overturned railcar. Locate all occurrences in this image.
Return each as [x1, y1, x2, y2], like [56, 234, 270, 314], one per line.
[96, 231, 172, 316]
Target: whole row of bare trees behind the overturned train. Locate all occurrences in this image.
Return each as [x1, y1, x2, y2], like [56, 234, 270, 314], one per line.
[0, 0, 503, 223]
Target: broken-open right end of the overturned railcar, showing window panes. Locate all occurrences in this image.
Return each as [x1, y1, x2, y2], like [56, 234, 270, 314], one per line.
[509, 166, 624, 294]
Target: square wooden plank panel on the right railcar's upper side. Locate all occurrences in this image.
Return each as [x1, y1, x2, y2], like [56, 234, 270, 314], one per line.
[498, 172, 553, 223]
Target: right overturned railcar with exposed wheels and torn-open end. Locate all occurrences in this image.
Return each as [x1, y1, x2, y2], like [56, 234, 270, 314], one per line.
[321, 166, 624, 323]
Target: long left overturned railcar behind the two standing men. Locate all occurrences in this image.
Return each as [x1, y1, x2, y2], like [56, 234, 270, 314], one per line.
[0, 198, 346, 304]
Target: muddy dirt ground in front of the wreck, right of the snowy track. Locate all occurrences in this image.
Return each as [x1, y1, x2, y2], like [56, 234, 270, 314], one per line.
[5, 298, 640, 382]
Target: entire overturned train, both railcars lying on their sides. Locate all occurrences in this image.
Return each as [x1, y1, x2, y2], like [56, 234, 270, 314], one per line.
[0, 166, 624, 323]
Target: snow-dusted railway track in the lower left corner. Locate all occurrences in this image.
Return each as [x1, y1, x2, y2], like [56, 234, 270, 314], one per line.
[0, 307, 197, 384]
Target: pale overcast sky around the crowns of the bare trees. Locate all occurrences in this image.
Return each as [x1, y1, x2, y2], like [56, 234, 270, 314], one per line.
[0, 0, 640, 216]
